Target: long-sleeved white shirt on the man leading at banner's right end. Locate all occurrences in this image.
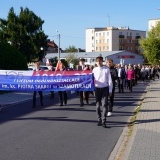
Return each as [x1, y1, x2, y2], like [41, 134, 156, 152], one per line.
[92, 66, 113, 93]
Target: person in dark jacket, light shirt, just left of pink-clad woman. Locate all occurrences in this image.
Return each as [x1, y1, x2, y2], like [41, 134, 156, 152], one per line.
[117, 64, 126, 93]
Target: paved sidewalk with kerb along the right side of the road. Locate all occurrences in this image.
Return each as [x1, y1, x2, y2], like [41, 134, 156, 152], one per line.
[109, 80, 160, 160]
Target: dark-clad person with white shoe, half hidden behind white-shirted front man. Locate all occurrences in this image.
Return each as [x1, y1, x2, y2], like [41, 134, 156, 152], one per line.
[106, 59, 118, 116]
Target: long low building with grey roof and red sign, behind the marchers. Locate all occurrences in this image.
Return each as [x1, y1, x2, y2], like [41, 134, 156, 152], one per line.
[45, 51, 144, 65]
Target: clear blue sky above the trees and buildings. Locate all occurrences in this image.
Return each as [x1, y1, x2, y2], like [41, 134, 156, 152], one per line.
[0, 0, 160, 50]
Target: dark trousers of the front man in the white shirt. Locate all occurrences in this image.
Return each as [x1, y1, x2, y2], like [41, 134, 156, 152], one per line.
[95, 87, 109, 123]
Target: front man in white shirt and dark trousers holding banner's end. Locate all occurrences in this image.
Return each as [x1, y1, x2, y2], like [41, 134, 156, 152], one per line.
[92, 57, 113, 128]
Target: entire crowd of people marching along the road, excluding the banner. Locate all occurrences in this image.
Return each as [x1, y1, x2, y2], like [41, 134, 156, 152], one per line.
[21, 57, 160, 128]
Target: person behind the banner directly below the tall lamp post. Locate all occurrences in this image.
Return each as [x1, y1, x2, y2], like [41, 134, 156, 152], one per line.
[56, 60, 67, 106]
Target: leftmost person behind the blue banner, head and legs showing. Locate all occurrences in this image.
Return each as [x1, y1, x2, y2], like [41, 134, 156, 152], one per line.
[32, 62, 43, 108]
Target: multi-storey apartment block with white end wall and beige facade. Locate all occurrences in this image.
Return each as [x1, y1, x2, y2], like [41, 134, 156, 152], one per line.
[86, 27, 146, 54]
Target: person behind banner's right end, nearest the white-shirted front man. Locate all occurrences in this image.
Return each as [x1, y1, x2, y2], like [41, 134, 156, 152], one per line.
[77, 58, 89, 107]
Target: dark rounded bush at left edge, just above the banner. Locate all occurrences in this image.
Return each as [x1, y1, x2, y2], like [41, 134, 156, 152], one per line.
[0, 42, 28, 70]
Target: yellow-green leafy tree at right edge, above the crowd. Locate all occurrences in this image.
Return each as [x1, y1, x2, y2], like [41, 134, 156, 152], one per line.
[140, 23, 160, 64]
